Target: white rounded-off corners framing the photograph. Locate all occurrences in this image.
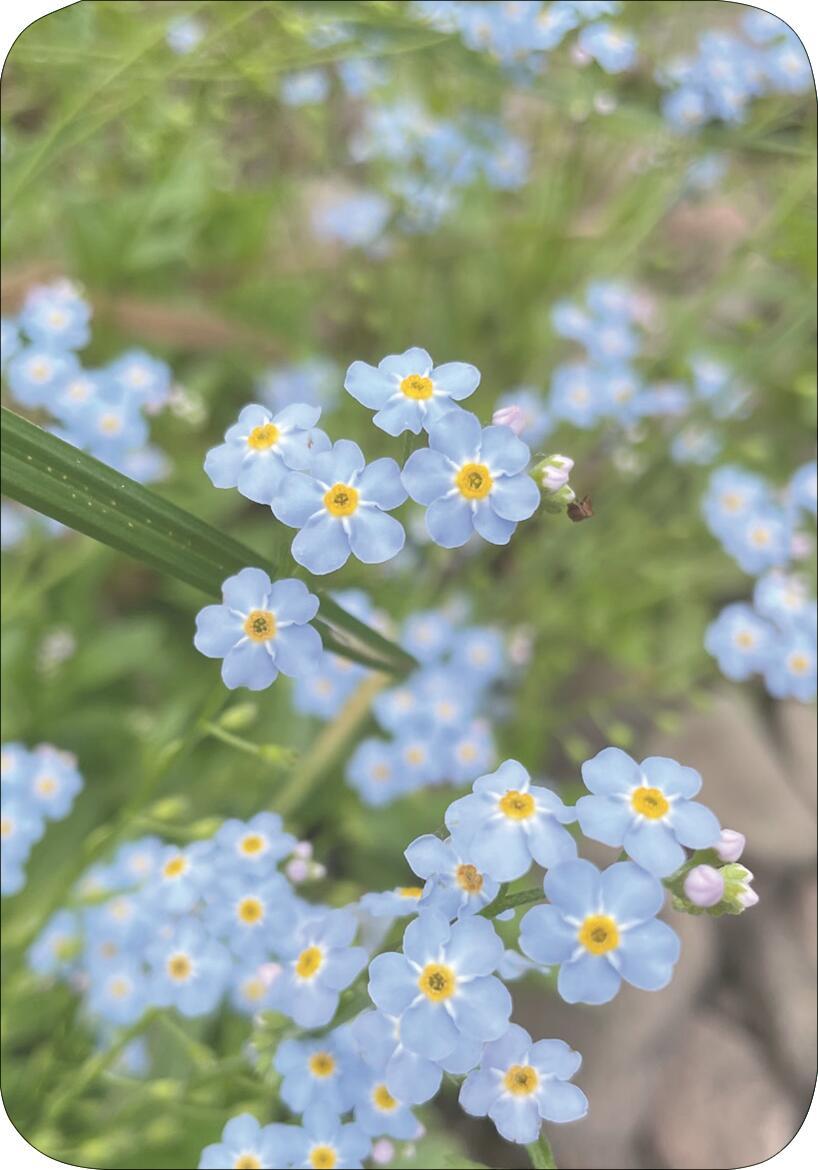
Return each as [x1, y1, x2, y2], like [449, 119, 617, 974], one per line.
[0, 0, 818, 1170]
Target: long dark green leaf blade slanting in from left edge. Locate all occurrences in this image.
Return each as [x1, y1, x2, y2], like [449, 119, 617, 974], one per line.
[0, 406, 417, 674]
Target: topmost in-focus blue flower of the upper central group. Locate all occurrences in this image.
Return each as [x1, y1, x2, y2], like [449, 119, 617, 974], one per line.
[344, 347, 480, 435]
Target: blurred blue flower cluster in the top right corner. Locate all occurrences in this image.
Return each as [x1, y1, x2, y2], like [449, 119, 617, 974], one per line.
[658, 9, 812, 132]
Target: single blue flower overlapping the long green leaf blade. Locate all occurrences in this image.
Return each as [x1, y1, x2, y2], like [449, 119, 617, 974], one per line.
[193, 569, 323, 690]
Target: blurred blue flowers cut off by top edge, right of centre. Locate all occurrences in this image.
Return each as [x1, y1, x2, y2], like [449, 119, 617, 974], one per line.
[412, 0, 637, 74]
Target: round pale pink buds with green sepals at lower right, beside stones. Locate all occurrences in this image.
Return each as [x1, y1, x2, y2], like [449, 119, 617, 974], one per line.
[667, 828, 758, 917]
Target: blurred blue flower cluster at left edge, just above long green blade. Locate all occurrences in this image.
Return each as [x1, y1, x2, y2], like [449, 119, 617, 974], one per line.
[2, 281, 171, 483]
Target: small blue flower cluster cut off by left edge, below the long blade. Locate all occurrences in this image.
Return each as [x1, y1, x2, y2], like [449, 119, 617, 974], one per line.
[0, 743, 82, 894]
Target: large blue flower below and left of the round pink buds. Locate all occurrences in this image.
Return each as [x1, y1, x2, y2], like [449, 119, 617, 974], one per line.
[520, 859, 680, 1004]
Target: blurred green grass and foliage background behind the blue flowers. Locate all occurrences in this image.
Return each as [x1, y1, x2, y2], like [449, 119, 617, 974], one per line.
[2, 0, 816, 1170]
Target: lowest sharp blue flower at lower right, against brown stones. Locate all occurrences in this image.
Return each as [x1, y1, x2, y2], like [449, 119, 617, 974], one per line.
[459, 1024, 587, 1145]
